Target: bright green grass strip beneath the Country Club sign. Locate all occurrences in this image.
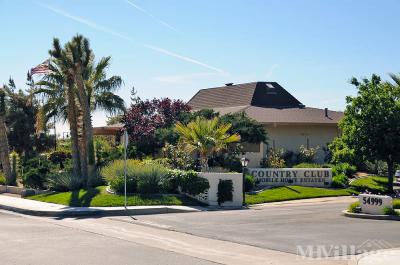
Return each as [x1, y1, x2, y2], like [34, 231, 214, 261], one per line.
[246, 186, 356, 204]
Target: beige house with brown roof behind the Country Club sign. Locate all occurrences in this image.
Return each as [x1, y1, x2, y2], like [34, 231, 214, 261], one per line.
[188, 82, 343, 167]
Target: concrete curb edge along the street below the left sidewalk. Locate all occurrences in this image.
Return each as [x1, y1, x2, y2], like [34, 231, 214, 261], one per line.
[0, 201, 207, 217]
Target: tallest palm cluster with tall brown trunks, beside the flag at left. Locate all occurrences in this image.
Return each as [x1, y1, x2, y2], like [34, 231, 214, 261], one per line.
[36, 36, 125, 186]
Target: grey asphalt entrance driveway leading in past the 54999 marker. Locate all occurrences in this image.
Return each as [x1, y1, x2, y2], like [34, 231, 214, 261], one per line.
[119, 199, 400, 256]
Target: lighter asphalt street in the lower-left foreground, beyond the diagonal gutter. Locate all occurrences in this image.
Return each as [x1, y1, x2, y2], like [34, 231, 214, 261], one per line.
[0, 211, 215, 265]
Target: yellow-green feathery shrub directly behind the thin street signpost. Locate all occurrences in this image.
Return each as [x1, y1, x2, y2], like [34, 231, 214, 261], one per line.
[100, 159, 141, 193]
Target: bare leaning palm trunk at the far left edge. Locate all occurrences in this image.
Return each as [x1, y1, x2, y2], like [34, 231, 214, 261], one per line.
[0, 88, 12, 185]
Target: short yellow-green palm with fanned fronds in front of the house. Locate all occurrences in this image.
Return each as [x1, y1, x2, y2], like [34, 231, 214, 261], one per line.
[175, 117, 240, 171]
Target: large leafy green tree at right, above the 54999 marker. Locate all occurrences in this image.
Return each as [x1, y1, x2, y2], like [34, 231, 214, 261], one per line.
[334, 75, 400, 192]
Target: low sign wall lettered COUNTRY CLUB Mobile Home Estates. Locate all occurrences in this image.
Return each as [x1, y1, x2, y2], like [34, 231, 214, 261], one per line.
[248, 168, 332, 187]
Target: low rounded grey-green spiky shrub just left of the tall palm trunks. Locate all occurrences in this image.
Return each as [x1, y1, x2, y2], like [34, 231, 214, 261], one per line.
[47, 172, 83, 191]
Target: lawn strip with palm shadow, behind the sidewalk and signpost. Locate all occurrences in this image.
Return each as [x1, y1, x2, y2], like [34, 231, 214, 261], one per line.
[27, 186, 199, 207]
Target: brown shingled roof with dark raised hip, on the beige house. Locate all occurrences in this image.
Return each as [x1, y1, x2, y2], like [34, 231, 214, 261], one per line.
[188, 82, 343, 125]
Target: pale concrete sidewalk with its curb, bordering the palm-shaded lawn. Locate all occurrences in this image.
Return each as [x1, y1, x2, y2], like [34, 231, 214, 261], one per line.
[0, 194, 206, 217]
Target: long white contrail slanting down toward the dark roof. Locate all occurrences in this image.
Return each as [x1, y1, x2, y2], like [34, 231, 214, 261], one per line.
[38, 3, 226, 73]
